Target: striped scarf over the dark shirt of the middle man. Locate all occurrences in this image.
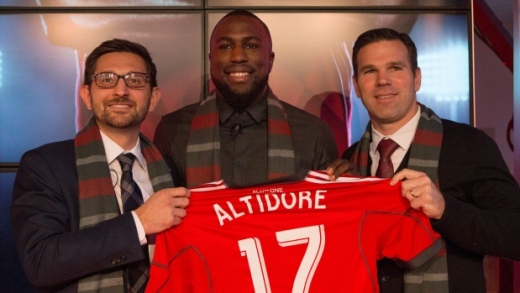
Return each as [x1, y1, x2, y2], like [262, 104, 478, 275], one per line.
[186, 90, 296, 187]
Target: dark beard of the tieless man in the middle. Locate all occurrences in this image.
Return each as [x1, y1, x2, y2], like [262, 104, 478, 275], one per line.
[213, 76, 268, 111]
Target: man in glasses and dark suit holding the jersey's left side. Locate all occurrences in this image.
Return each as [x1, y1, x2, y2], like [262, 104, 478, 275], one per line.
[11, 39, 189, 292]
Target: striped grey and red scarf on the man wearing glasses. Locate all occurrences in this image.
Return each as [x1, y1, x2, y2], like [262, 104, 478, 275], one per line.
[74, 117, 173, 293]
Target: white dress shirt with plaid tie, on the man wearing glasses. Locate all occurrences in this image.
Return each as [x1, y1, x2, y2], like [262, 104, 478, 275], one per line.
[100, 131, 153, 245]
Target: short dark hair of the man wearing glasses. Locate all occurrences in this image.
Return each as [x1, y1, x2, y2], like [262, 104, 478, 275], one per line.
[83, 39, 157, 88]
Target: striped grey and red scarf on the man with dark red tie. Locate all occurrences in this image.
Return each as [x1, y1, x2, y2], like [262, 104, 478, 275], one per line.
[351, 103, 449, 293]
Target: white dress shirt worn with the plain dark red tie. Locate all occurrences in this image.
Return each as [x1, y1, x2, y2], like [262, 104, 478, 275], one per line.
[370, 107, 421, 175]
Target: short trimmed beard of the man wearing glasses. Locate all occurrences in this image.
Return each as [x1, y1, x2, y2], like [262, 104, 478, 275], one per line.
[91, 98, 150, 128]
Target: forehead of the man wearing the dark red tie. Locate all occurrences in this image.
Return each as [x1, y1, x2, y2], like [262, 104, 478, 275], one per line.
[357, 40, 410, 67]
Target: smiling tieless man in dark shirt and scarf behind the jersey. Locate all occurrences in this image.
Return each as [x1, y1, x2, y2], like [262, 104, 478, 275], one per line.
[154, 10, 338, 187]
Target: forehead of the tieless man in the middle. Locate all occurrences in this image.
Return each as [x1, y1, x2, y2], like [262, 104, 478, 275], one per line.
[211, 15, 270, 43]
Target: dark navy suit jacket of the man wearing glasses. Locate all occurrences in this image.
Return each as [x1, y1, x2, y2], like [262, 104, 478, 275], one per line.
[11, 140, 148, 292]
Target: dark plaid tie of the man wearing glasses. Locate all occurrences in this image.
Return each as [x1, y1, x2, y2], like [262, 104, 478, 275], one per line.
[117, 153, 150, 293]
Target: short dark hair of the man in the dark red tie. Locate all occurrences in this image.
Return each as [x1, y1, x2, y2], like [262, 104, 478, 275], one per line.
[352, 28, 418, 78]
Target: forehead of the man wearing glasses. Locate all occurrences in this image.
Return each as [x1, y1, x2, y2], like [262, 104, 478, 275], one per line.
[96, 52, 147, 73]
